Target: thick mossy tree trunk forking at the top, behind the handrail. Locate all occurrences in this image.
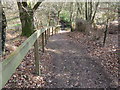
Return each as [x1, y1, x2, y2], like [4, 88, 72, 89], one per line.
[17, 2, 41, 37]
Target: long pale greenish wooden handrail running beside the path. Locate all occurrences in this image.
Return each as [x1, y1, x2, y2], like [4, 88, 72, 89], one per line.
[0, 26, 59, 89]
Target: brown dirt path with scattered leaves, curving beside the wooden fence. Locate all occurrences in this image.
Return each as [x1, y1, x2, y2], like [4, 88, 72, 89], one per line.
[44, 33, 111, 88]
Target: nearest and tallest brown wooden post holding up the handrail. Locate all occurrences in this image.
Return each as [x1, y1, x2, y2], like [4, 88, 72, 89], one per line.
[34, 40, 41, 75]
